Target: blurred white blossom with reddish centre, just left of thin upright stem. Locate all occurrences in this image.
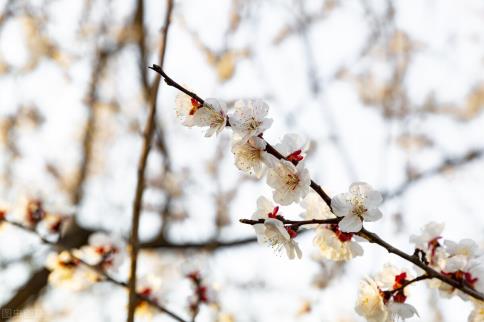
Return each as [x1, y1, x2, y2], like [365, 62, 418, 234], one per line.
[74, 233, 127, 271]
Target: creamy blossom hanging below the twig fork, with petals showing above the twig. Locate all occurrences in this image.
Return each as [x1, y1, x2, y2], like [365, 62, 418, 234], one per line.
[301, 192, 363, 261]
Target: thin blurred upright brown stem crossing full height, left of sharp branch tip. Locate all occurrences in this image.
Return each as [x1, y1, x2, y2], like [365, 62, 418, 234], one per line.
[127, 0, 173, 322]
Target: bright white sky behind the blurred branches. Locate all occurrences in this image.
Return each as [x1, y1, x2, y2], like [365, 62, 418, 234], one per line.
[0, 0, 484, 322]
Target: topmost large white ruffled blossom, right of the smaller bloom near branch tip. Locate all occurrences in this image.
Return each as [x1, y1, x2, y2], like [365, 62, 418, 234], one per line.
[230, 100, 272, 143]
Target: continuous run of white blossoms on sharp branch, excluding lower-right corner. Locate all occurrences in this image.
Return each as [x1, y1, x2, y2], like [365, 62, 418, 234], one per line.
[176, 94, 383, 261]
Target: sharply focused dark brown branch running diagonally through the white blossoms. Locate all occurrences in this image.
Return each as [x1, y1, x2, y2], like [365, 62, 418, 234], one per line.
[151, 65, 484, 301]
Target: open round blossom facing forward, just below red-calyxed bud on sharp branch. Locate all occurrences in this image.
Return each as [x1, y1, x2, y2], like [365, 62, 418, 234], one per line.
[267, 160, 311, 205]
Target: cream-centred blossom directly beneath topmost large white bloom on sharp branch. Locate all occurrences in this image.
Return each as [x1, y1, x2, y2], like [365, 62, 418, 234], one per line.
[232, 136, 277, 178]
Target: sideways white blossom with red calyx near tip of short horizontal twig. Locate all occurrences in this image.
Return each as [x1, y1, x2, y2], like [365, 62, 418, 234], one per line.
[252, 197, 302, 259]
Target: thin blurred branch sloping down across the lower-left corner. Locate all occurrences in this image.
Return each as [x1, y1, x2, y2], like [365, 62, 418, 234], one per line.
[0, 218, 186, 322]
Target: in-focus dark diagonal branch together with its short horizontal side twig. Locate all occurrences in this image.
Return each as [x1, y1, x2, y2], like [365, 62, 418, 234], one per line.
[149, 64, 484, 301]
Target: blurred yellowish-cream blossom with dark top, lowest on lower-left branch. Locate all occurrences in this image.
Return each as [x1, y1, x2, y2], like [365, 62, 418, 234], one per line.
[45, 251, 100, 291]
